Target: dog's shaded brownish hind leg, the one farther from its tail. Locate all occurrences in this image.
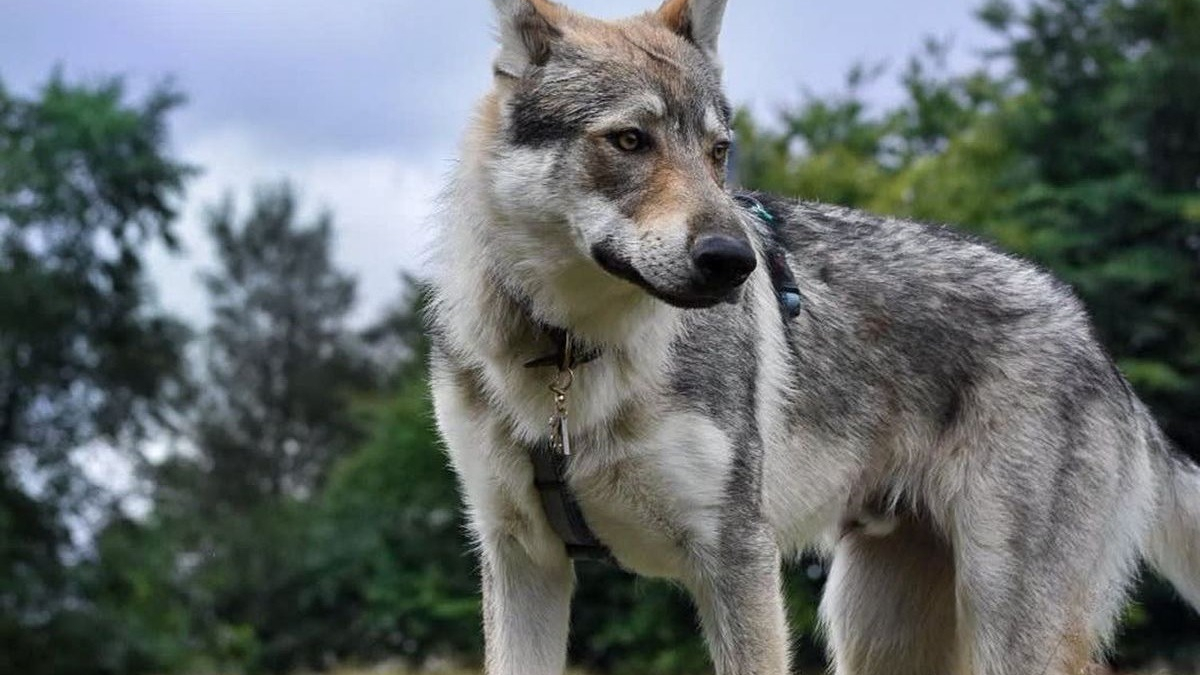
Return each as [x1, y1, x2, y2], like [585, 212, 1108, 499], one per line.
[821, 518, 968, 675]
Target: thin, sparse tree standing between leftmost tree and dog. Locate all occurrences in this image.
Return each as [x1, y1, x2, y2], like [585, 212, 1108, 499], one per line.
[138, 184, 374, 671]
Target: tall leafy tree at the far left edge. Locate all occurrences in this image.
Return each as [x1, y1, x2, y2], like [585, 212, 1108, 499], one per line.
[0, 74, 194, 673]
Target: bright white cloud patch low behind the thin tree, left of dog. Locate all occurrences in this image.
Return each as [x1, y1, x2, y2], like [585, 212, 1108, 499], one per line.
[149, 127, 442, 327]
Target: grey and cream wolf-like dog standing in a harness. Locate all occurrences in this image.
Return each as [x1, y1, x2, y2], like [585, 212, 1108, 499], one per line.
[428, 0, 1200, 675]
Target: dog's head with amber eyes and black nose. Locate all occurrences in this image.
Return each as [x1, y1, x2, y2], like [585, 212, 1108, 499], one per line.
[488, 0, 756, 307]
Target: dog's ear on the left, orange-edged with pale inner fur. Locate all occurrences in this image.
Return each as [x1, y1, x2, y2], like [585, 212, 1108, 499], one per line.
[492, 0, 566, 78]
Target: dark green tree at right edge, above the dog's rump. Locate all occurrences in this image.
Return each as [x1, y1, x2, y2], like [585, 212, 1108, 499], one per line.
[984, 0, 1200, 459]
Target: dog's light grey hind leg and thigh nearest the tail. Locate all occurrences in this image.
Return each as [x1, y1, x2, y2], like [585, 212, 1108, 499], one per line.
[950, 406, 1153, 675]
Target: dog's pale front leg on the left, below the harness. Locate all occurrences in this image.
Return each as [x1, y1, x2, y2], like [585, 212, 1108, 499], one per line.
[481, 537, 574, 675]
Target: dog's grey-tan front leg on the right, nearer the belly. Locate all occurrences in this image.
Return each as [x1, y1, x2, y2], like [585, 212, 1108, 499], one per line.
[689, 524, 788, 675]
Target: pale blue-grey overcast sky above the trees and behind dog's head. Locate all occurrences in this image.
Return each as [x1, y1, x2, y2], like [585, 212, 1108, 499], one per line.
[0, 0, 988, 323]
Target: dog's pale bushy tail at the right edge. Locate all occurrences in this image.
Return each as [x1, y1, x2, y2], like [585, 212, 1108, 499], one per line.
[1146, 422, 1200, 611]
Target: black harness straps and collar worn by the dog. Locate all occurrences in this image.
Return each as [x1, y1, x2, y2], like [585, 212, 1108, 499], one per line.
[524, 193, 802, 565]
